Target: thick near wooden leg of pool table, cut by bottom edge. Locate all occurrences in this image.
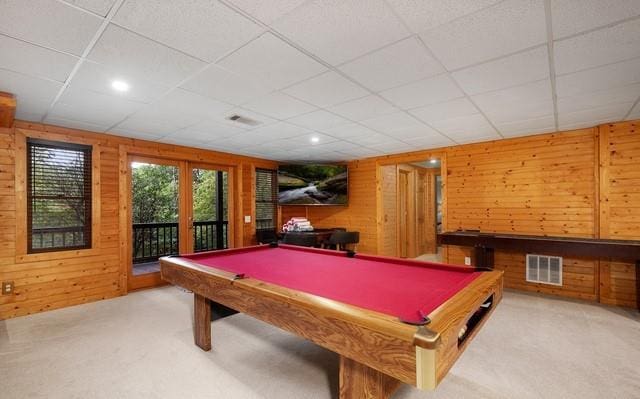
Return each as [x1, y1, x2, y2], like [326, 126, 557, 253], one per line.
[340, 356, 401, 399]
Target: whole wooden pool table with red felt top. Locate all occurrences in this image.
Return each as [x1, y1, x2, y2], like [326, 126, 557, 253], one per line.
[160, 244, 502, 399]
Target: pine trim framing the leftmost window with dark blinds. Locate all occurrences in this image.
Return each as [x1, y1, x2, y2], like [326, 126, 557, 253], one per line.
[14, 128, 102, 263]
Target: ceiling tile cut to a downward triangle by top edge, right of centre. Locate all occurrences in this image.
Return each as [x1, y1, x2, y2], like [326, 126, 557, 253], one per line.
[387, 0, 501, 33]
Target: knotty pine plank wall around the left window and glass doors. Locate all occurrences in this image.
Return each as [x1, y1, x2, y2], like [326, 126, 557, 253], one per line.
[0, 121, 276, 319]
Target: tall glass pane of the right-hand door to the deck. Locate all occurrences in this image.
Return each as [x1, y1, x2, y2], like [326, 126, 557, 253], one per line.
[190, 167, 229, 252]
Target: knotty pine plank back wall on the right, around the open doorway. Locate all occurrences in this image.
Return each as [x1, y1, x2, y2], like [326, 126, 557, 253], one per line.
[282, 121, 640, 306]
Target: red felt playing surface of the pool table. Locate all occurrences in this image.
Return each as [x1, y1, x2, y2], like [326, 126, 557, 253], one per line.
[182, 245, 481, 322]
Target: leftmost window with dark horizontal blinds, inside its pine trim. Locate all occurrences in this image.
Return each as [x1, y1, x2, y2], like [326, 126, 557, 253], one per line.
[27, 139, 92, 253]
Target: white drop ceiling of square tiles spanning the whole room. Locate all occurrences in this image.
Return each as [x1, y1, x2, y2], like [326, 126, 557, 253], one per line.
[0, 0, 640, 161]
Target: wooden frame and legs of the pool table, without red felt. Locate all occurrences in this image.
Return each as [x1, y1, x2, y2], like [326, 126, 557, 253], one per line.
[160, 250, 502, 399]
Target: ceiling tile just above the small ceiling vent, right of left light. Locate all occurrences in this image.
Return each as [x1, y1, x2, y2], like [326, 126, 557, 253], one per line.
[181, 65, 272, 105]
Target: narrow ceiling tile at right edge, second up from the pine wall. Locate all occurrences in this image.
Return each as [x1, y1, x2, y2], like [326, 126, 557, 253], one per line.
[558, 83, 640, 114]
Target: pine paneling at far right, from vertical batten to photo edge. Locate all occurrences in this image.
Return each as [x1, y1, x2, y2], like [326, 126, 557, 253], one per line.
[599, 121, 640, 306]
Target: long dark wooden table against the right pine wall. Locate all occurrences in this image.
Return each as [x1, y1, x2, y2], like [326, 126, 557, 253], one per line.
[438, 231, 640, 310]
